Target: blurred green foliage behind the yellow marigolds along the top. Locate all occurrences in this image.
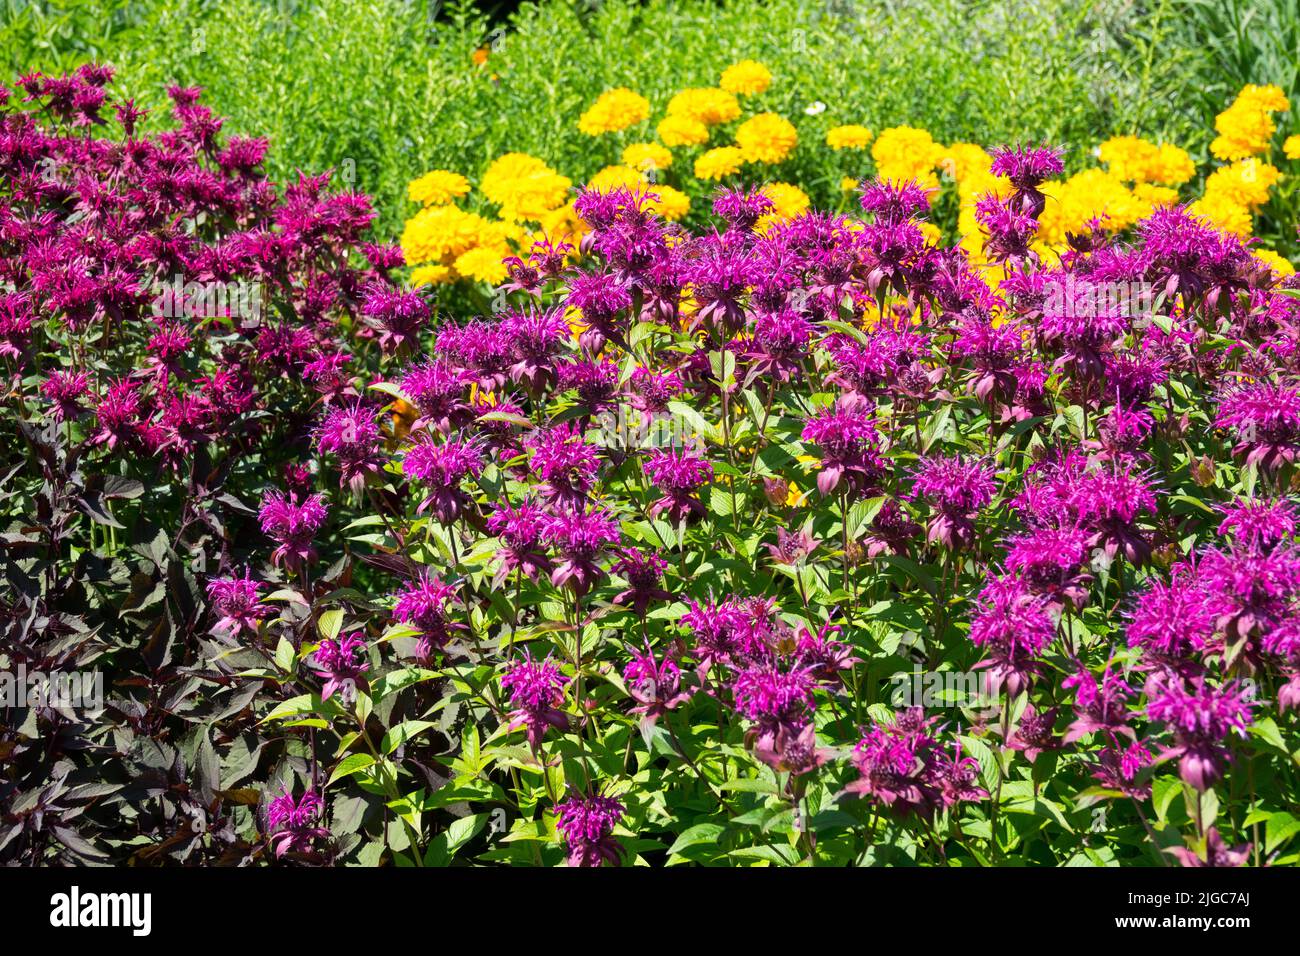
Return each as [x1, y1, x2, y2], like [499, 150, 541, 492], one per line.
[0, 0, 1300, 243]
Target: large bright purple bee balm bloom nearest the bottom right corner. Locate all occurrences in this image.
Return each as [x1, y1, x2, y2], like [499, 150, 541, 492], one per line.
[1147, 676, 1255, 791]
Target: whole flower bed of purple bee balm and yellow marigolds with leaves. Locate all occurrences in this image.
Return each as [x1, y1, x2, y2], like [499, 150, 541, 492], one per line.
[0, 52, 1300, 868]
